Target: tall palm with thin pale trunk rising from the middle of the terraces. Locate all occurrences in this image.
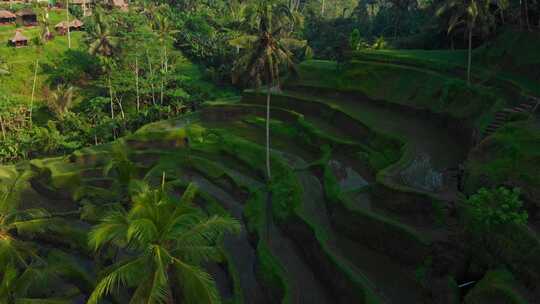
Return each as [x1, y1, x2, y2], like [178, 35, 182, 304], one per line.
[230, 0, 307, 180]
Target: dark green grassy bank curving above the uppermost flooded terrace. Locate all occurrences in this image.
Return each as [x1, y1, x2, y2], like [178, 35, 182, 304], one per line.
[294, 60, 498, 126]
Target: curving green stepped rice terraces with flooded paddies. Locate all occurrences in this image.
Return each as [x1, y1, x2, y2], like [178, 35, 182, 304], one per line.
[2, 78, 480, 303]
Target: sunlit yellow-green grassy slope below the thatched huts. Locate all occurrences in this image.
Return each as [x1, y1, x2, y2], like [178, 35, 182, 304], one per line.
[0, 10, 83, 103]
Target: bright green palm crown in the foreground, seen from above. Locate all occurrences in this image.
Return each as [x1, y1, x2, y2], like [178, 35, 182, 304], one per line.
[88, 184, 240, 304]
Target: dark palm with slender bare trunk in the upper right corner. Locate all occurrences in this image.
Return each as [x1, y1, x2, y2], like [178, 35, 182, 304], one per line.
[437, 0, 493, 84]
